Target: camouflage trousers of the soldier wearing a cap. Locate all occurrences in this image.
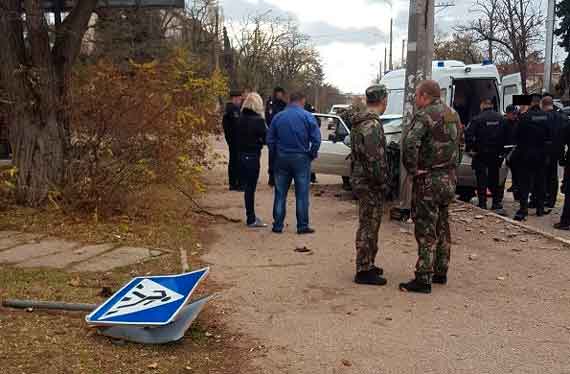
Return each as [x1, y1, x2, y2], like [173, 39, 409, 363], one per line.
[356, 191, 384, 272]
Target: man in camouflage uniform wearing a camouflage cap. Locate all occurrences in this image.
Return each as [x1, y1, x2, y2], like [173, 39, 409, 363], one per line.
[345, 85, 388, 286]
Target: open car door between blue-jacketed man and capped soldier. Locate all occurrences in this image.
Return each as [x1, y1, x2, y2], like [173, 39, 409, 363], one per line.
[312, 114, 350, 176]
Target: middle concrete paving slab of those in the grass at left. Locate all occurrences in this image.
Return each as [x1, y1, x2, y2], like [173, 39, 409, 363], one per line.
[18, 243, 115, 269]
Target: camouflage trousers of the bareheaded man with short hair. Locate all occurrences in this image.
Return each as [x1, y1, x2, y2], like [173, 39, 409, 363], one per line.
[414, 199, 451, 283]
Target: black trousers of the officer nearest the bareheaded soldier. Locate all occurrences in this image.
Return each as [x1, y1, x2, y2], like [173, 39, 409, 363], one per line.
[473, 154, 505, 207]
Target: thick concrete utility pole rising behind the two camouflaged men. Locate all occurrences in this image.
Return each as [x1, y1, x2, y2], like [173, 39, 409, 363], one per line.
[398, 0, 435, 217]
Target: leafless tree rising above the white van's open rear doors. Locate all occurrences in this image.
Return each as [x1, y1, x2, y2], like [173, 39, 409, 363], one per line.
[458, 0, 544, 93]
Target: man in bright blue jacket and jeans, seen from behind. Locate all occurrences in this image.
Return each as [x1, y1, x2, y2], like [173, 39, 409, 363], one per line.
[267, 93, 321, 234]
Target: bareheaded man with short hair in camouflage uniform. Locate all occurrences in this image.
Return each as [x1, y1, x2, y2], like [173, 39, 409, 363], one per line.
[400, 80, 463, 293]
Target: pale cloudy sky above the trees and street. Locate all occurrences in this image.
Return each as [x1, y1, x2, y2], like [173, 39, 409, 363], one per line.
[221, 0, 556, 93]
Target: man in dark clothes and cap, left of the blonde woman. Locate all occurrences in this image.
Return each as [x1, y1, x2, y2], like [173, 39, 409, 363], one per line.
[222, 90, 242, 191]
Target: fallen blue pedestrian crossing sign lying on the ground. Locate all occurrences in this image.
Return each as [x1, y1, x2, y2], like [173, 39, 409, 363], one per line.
[85, 268, 209, 326]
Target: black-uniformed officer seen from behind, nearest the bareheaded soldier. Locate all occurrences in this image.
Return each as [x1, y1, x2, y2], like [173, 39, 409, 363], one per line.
[465, 98, 508, 210]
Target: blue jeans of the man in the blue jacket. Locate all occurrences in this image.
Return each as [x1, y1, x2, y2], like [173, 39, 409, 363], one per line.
[273, 153, 311, 231]
